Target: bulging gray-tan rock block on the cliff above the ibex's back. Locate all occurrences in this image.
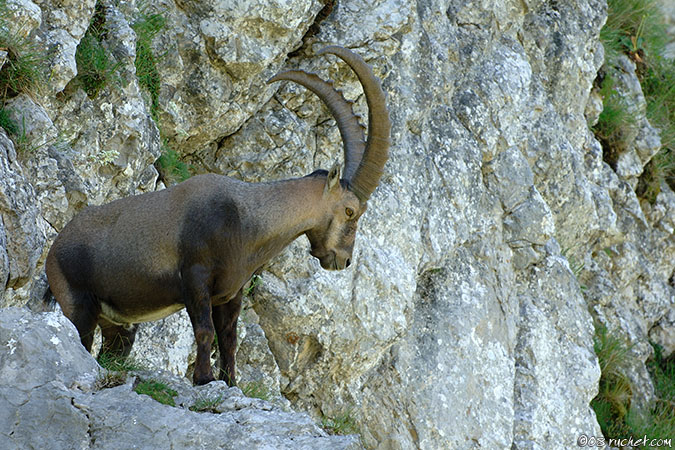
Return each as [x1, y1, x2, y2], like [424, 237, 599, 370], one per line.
[137, 0, 320, 153]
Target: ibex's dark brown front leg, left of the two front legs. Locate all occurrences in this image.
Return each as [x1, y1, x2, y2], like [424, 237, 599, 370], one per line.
[182, 265, 215, 384]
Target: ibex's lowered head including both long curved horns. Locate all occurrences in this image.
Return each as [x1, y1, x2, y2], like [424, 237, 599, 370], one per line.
[269, 46, 391, 270]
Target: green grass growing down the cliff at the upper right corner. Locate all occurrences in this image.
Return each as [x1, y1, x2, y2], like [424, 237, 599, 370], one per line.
[594, 0, 675, 203]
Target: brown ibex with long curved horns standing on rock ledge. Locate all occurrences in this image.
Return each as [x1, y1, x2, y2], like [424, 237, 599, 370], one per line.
[45, 46, 391, 385]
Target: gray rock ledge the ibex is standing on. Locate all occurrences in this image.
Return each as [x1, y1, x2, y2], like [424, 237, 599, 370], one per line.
[0, 308, 362, 450]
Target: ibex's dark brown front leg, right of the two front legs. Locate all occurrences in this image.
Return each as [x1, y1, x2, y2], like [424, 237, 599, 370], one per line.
[213, 290, 241, 386]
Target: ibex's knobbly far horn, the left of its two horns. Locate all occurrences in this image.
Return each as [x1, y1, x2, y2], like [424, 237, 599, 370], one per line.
[267, 70, 366, 179]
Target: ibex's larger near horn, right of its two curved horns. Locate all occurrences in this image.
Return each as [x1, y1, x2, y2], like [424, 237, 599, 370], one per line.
[317, 46, 391, 201]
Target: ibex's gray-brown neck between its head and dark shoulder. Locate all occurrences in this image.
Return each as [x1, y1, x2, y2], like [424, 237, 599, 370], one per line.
[250, 177, 325, 267]
